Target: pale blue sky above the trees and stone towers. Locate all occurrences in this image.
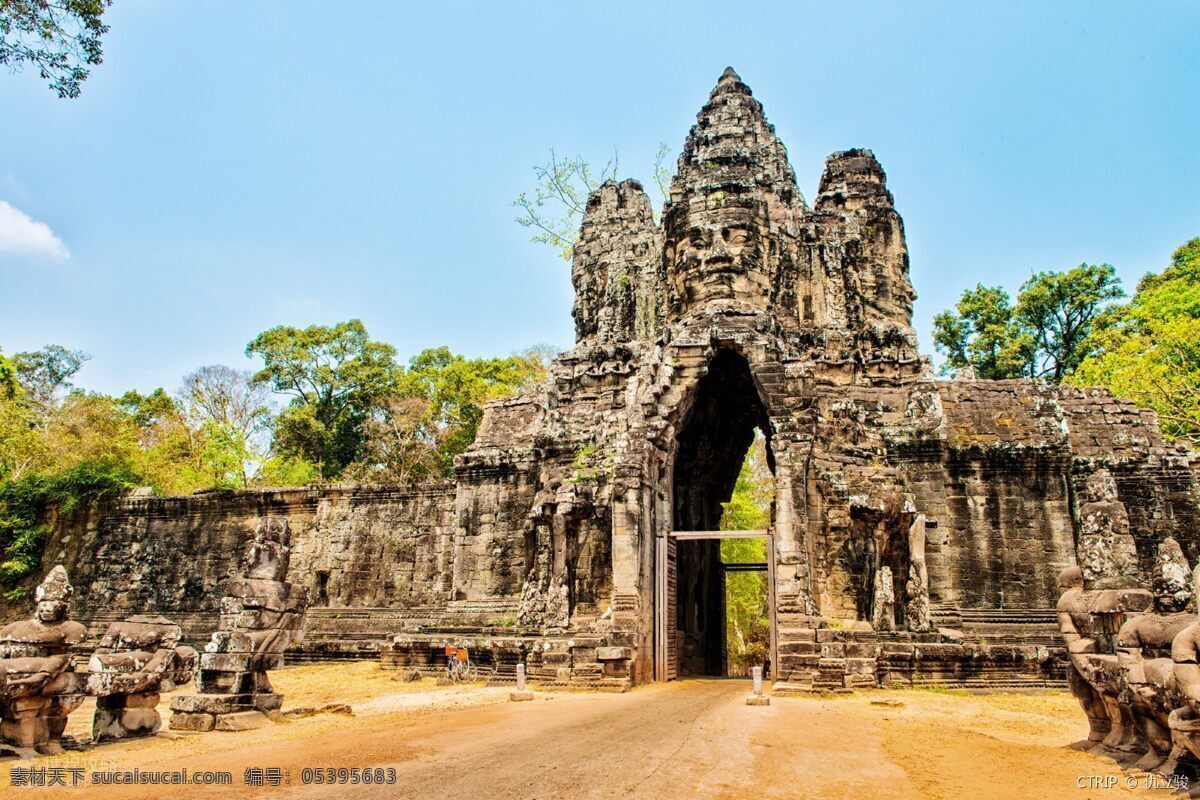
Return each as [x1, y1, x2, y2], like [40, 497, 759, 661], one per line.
[0, 0, 1200, 392]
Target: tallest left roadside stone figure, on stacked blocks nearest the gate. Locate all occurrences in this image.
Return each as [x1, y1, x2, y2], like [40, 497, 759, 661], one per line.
[170, 517, 308, 730]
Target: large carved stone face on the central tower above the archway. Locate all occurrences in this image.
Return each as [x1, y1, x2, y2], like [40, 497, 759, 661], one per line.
[667, 209, 766, 309]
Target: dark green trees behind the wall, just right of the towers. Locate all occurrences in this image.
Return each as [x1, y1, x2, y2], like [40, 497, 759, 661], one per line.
[934, 264, 1123, 383]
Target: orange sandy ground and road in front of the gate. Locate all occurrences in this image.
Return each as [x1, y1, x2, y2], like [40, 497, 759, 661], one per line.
[0, 663, 1170, 800]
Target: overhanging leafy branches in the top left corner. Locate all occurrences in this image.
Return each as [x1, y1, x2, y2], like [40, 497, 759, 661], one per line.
[0, 0, 113, 97]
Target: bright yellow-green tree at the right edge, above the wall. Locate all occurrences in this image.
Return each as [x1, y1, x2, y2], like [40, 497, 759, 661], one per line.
[1070, 236, 1200, 444]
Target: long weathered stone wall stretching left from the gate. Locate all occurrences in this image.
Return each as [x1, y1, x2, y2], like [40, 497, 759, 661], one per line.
[10, 483, 456, 620]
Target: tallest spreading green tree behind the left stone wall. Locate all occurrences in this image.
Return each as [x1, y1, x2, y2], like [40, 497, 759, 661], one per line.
[246, 319, 401, 480]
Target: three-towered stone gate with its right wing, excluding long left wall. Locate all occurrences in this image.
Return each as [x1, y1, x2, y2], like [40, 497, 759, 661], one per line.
[454, 70, 1195, 684]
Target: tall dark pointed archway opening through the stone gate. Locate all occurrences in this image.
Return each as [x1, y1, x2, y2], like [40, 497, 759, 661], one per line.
[656, 348, 774, 680]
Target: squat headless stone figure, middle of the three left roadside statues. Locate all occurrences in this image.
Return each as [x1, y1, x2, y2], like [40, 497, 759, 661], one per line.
[88, 614, 196, 741]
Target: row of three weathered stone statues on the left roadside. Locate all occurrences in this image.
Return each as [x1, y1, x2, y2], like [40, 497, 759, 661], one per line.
[0, 517, 308, 756]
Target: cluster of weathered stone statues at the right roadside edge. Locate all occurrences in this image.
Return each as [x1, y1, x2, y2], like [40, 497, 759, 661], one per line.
[1058, 470, 1200, 775]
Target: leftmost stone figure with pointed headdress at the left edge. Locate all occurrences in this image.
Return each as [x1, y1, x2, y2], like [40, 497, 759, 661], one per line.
[0, 565, 88, 753]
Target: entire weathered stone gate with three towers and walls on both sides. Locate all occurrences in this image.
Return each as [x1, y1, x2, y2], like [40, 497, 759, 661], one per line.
[30, 70, 1200, 687]
